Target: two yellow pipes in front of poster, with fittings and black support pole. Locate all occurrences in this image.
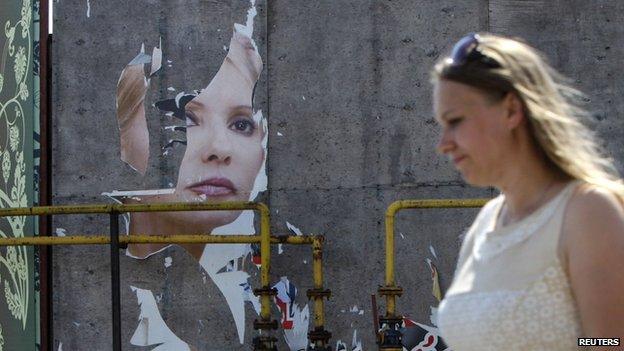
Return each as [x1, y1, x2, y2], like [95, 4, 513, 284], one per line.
[0, 202, 331, 351]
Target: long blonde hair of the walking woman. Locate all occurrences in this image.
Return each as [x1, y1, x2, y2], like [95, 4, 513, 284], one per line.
[432, 33, 624, 201]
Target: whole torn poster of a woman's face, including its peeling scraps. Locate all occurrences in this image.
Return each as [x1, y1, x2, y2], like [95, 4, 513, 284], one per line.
[107, 1, 280, 349]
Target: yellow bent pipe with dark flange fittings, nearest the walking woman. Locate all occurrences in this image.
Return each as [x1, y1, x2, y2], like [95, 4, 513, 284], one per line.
[373, 199, 489, 351]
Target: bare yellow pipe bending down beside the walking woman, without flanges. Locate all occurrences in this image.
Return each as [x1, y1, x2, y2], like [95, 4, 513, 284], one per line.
[385, 199, 489, 317]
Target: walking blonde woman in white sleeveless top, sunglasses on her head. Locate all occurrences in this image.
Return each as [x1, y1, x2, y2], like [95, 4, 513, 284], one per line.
[433, 34, 624, 351]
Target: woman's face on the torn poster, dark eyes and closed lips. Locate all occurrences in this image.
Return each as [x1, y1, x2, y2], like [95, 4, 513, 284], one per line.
[175, 32, 265, 225]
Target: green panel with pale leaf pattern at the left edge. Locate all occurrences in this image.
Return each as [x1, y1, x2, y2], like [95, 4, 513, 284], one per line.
[0, 0, 39, 351]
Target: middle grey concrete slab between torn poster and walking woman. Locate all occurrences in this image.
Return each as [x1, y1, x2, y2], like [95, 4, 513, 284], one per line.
[268, 1, 489, 349]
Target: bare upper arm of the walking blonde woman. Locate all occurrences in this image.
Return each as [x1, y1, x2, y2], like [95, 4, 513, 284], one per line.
[562, 187, 624, 350]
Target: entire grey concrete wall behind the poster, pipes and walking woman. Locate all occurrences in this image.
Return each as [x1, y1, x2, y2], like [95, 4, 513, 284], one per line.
[53, 0, 624, 350]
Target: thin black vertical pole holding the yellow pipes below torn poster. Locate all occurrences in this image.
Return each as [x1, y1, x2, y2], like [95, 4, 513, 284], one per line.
[110, 212, 121, 351]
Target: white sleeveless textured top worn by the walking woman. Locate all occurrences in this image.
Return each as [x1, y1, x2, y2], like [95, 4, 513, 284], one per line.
[438, 182, 581, 351]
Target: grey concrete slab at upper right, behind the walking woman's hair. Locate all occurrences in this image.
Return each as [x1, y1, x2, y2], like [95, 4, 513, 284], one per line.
[490, 0, 624, 172]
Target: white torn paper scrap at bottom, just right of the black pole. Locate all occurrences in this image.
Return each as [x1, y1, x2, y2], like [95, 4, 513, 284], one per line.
[130, 286, 191, 351]
